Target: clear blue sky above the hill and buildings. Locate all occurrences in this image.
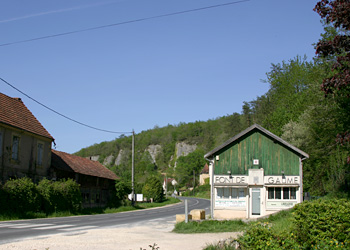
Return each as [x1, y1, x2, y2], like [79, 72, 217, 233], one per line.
[0, 0, 323, 153]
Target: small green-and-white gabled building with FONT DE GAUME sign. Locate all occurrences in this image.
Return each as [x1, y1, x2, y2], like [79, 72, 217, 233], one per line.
[204, 124, 309, 219]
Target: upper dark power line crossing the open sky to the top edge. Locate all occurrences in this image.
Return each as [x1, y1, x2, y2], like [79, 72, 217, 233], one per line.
[0, 0, 250, 47]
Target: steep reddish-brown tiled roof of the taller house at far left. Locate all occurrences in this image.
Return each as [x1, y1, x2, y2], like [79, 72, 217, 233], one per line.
[0, 93, 54, 140]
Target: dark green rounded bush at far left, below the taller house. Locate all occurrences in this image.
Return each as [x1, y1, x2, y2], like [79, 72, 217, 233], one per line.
[3, 177, 40, 214]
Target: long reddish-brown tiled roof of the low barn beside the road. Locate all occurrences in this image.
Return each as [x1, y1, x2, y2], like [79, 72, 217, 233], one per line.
[51, 150, 119, 180]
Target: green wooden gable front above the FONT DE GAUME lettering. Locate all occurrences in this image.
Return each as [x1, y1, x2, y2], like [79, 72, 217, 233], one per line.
[214, 130, 299, 175]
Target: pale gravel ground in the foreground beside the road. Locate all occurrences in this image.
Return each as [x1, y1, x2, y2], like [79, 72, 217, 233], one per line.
[0, 220, 241, 250]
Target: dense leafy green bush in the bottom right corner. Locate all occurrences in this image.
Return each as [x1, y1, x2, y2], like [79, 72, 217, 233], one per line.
[293, 199, 350, 248]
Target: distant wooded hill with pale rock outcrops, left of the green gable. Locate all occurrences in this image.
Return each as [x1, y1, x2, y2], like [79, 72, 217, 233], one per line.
[75, 113, 249, 187]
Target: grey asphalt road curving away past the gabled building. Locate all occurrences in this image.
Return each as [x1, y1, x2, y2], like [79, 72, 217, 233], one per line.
[0, 198, 210, 245]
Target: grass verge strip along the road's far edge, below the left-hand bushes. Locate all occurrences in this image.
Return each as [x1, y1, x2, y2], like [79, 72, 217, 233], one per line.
[0, 197, 181, 221]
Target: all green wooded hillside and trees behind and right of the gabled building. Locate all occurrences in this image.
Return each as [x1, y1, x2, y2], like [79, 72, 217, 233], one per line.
[76, 22, 350, 195]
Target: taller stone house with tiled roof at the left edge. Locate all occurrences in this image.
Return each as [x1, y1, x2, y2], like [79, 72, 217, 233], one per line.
[0, 93, 54, 182]
